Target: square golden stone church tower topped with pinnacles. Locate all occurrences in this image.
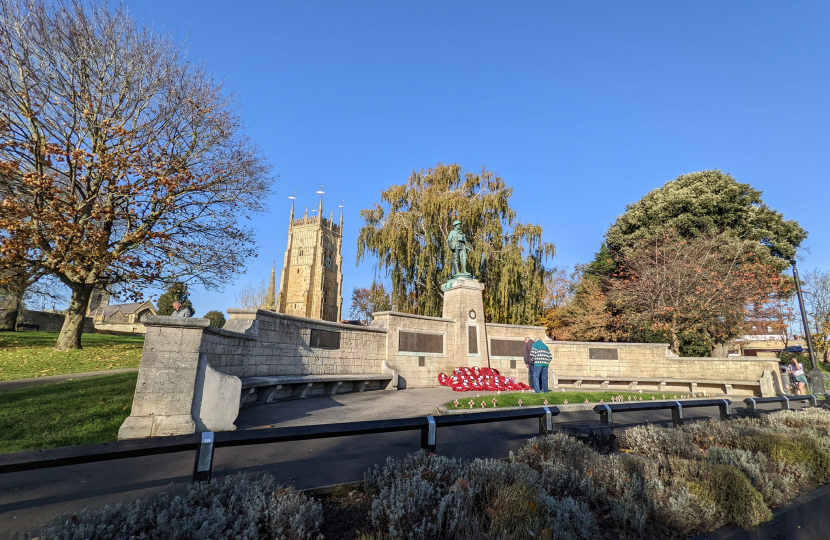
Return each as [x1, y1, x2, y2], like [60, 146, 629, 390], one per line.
[277, 198, 343, 322]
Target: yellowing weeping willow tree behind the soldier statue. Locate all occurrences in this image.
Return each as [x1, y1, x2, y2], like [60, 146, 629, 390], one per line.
[357, 163, 555, 324]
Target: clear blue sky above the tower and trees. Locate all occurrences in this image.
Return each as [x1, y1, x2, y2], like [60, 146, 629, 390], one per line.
[105, 0, 830, 316]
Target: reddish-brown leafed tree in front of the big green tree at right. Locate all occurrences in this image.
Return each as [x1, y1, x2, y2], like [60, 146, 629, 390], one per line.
[609, 231, 792, 356]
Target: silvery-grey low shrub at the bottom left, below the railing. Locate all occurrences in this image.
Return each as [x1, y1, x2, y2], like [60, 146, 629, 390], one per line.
[18, 475, 323, 540]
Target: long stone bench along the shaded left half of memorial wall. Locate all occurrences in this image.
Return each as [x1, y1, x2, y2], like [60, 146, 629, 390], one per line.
[240, 373, 394, 404]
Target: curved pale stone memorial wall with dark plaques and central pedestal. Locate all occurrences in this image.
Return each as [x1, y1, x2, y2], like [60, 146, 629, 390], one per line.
[119, 304, 780, 438]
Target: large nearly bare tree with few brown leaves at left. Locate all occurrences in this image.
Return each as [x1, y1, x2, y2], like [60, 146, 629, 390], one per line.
[0, 0, 272, 350]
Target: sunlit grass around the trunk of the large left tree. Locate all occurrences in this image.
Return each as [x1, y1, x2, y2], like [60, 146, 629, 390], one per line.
[0, 332, 144, 381]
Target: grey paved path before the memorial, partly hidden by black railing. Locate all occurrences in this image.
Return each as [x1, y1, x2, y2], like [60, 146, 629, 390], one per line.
[0, 388, 808, 538]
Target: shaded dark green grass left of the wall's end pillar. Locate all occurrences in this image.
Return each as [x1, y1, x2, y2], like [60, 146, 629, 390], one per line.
[0, 373, 138, 453]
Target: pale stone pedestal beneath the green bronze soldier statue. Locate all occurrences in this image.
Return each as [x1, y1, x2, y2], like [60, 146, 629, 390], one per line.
[441, 276, 489, 367]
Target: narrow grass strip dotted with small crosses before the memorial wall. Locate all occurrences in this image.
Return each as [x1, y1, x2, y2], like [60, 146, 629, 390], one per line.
[445, 392, 688, 409]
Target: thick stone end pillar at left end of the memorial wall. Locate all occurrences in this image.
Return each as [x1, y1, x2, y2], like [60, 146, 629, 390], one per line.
[118, 315, 210, 440]
